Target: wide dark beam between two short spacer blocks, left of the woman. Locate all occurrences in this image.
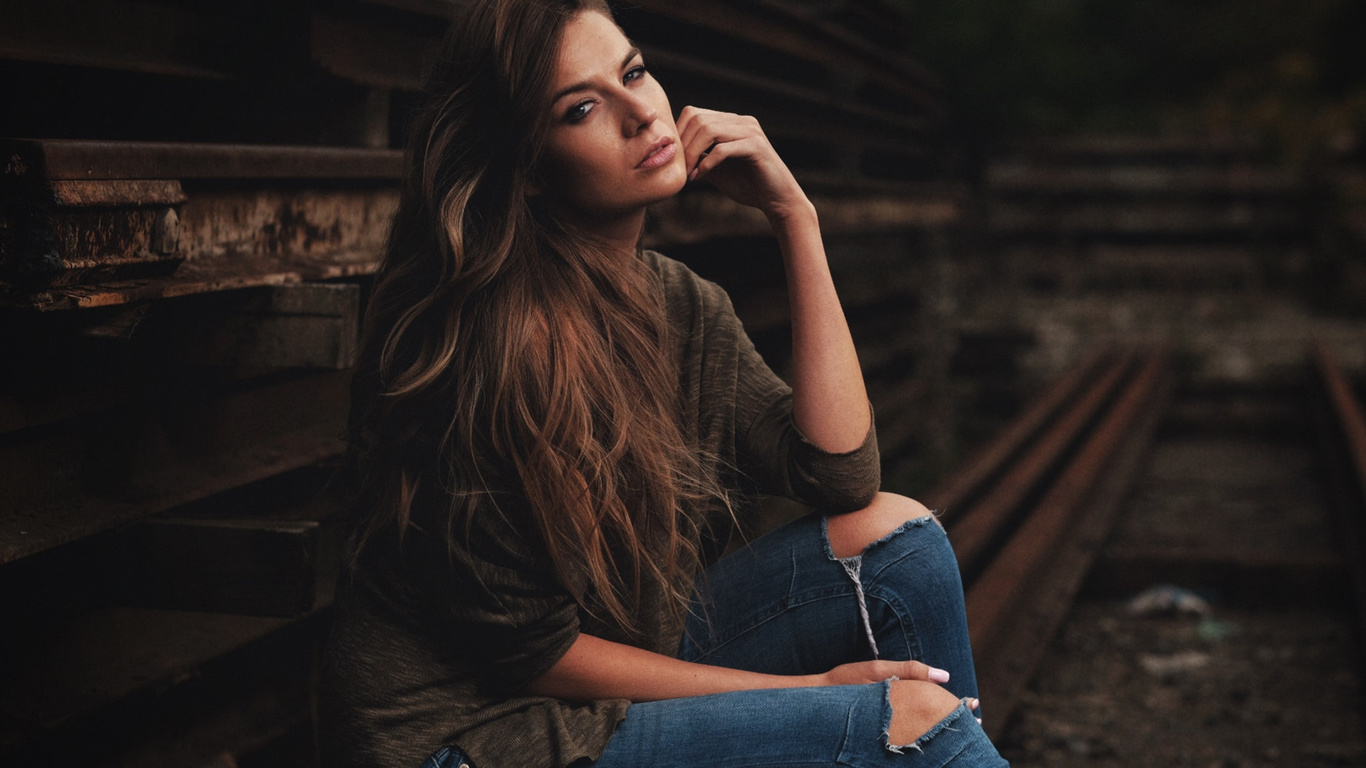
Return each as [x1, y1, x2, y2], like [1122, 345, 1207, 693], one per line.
[0, 372, 350, 564]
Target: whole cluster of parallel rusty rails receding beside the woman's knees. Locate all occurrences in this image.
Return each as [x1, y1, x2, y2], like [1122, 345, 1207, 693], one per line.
[928, 350, 1169, 735]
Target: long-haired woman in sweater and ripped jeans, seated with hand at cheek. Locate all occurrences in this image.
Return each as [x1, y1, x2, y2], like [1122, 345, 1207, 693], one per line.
[322, 0, 1003, 768]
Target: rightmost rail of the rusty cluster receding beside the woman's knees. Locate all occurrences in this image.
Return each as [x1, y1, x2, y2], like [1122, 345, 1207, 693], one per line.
[967, 350, 1173, 738]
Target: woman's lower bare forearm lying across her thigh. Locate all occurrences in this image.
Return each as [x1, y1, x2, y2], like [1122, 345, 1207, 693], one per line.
[526, 634, 820, 701]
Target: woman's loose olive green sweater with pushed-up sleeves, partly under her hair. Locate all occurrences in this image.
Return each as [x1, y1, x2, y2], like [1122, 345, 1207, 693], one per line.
[320, 251, 880, 768]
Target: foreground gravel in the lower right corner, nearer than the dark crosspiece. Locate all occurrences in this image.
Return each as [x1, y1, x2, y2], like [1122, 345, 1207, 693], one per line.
[999, 601, 1366, 768]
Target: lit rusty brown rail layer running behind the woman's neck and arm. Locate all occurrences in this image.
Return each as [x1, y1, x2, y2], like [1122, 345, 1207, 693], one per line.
[0, 141, 959, 310]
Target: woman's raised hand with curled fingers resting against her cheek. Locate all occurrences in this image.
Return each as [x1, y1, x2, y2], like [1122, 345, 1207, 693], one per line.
[678, 107, 811, 220]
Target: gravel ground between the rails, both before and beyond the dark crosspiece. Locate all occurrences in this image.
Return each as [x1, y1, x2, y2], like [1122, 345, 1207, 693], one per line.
[984, 390, 1366, 768]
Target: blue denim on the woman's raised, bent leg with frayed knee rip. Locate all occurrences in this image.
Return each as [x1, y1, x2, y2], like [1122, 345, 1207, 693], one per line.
[679, 515, 977, 697]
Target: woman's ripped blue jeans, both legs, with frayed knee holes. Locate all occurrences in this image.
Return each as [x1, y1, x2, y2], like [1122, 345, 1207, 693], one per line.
[593, 515, 1007, 768]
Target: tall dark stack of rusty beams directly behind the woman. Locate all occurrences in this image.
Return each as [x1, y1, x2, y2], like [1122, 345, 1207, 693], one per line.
[0, 0, 962, 765]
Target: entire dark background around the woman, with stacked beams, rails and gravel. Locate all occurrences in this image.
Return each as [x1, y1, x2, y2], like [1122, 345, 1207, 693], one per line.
[0, 0, 1366, 768]
